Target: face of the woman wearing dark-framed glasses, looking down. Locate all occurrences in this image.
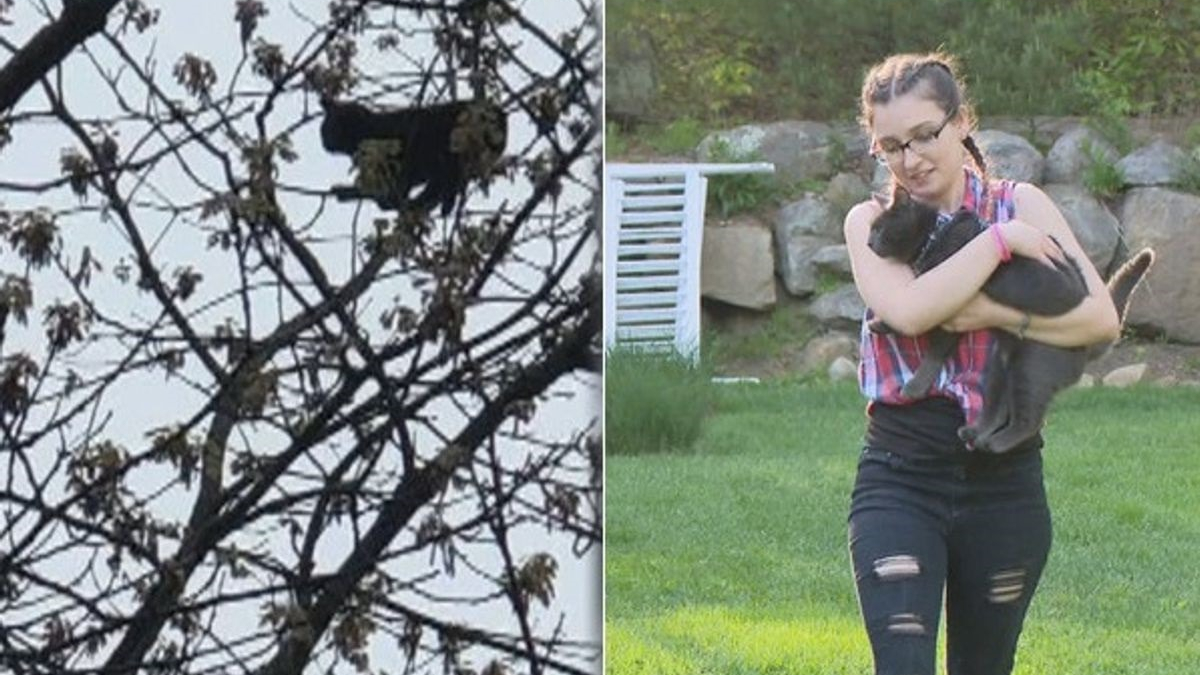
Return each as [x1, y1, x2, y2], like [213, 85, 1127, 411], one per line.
[872, 88, 966, 210]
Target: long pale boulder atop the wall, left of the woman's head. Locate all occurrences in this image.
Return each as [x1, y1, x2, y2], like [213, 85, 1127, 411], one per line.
[696, 121, 845, 183]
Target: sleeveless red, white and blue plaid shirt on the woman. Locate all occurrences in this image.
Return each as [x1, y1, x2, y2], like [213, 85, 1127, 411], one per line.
[858, 171, 1014, 424]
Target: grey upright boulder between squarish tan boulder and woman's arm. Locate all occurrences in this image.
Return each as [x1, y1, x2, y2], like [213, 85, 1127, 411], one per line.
[774, 195, 841, 298]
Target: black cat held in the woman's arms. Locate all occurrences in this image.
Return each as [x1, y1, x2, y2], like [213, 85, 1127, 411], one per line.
[868, 190, 1154, 453]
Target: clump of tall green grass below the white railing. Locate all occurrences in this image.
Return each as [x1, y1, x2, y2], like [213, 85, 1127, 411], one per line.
[605, 348, 713, 454]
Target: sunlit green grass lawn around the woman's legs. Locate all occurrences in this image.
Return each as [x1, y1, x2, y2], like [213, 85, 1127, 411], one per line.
[605, 382, 1200, 675]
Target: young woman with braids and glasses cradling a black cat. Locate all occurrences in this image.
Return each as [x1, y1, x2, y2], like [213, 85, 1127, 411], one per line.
[845, 54, 1118, 675]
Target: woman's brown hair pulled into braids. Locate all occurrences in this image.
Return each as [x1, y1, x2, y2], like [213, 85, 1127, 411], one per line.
[858, 52, 988, 185]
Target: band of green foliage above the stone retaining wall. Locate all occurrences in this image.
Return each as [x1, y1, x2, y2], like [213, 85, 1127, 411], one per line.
[605, 0, 1200, 125]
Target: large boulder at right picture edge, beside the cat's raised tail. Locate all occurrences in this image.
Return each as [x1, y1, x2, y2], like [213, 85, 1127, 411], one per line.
[1120, 187, 1200, 344]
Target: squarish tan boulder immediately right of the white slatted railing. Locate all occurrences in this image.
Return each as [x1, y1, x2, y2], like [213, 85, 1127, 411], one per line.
[700, 220, 775, 310]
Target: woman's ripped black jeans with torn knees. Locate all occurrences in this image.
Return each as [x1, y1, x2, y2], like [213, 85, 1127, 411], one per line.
[850, 448, 1051, 675]
